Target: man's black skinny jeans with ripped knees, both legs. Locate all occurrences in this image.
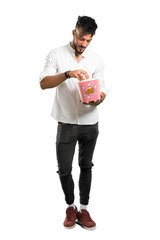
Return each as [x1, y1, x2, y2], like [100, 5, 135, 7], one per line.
[56, 122, 99, 205]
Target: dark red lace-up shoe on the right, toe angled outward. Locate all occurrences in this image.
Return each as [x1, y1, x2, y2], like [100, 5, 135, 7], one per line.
[77, 209, 96, 230]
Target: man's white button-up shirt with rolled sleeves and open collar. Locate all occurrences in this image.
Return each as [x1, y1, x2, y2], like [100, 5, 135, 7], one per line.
[40, 43, 108, 125]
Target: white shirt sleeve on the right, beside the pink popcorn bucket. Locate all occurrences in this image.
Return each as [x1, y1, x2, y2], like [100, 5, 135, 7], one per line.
[93, 58, 109, 96]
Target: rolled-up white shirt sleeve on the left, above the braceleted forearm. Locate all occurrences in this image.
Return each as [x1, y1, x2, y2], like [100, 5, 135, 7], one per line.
[39, 50, 57, 82]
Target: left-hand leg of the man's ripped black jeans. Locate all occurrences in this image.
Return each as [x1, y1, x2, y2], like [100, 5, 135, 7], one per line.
[56, 123, 77, 204]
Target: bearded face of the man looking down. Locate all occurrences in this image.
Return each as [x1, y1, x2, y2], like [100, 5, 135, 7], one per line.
[73, 28, 92, 54]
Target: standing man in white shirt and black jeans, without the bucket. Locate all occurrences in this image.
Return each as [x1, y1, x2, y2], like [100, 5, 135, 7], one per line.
[40, 16, 107, 229]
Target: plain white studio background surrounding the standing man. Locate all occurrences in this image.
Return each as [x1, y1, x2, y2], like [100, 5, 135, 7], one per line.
[0, 0, 160, 240]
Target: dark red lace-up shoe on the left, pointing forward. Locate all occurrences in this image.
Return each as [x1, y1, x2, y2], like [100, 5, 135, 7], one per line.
[63, 207, 78, 228]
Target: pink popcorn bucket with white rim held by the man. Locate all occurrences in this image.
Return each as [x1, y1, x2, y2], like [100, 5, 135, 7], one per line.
[78, 78, 100, 102]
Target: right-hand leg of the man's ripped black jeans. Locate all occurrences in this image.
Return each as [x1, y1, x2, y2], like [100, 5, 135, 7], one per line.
[78, 123, 98, 205]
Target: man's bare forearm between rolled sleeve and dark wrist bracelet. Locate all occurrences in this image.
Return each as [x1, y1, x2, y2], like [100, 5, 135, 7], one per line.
[40, 73, 66, 90]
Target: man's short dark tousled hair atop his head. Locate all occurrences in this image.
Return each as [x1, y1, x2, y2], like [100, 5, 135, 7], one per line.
[76, 16, 98, 36]
